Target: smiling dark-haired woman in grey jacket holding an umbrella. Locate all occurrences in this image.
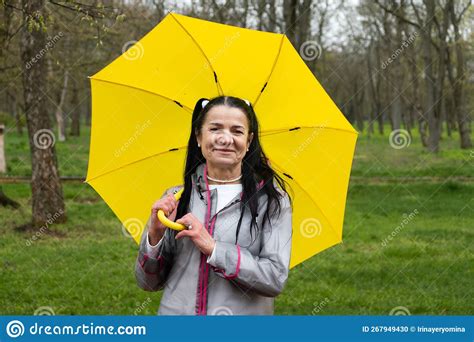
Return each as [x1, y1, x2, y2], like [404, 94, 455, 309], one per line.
[135, 96, 292, 315]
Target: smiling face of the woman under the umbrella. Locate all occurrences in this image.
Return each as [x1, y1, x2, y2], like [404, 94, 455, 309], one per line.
[196, 105, 253, 165]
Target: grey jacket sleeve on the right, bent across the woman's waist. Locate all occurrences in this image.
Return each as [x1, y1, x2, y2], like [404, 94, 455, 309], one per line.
[212, 194, 293, 297]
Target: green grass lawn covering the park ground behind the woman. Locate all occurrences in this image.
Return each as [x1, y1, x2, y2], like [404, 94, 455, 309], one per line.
[0, 121, 474, 315]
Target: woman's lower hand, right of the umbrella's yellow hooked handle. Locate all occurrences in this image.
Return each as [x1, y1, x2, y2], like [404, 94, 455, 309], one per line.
[176, 213, 216, 255]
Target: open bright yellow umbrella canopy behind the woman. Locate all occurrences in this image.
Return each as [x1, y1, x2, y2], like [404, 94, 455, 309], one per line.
[86, 13, 357, 267]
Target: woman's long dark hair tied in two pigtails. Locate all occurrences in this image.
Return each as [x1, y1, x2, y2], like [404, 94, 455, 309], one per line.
[176, 96, 292, 244]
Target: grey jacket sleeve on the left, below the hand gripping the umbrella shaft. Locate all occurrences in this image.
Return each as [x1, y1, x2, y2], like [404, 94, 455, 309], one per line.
[135, 190, 180, 291]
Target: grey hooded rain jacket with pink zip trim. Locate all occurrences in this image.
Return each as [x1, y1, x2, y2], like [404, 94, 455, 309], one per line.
[135, 163, 292, 315]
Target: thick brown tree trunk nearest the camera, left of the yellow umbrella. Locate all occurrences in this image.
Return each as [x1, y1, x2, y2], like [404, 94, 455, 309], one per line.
[21, 0, 66, 228]
